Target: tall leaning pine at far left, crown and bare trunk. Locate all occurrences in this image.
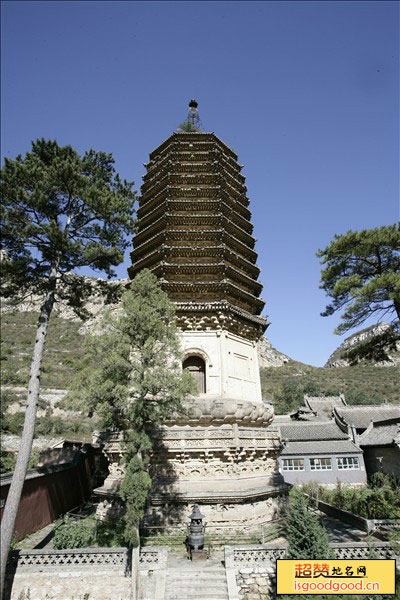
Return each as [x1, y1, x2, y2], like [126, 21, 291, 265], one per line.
[0, 139, 135, 585]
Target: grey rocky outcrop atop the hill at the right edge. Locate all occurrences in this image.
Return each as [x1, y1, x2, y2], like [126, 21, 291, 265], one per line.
[324, 322, 400, 368]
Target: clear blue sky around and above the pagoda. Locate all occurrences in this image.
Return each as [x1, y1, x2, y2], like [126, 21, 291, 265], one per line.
[2, 1, 399, 366]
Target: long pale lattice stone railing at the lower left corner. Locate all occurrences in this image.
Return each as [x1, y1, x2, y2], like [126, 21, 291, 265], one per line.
[10, 548, 130, 574]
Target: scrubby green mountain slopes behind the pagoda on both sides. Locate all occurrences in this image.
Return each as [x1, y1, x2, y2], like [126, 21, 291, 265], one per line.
[1, 280, 400, 403]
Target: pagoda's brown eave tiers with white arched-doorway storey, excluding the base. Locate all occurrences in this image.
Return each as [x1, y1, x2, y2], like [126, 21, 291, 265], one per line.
[129, 133, 267, 402]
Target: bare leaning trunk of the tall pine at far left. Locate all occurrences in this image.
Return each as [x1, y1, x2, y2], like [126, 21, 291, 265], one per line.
[0, 266, 57, 598]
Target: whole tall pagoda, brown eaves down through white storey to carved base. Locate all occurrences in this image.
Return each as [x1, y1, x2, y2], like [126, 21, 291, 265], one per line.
[100, 125, 287, 532]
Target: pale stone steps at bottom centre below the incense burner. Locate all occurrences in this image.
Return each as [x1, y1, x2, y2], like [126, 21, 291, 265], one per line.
[165, 566, 228, 600]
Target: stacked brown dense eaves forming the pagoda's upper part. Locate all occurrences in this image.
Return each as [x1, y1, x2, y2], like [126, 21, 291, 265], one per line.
[129, 133, 266, 329]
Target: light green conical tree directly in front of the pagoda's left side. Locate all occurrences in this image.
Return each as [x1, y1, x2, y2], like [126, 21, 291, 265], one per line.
[71, 269, 194, 544]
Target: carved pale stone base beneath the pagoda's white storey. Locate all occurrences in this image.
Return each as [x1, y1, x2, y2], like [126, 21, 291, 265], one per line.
[95, 395, 288, 534]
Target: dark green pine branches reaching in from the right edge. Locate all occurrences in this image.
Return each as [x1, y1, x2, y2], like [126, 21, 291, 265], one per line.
[317, 224, 400, 334]
